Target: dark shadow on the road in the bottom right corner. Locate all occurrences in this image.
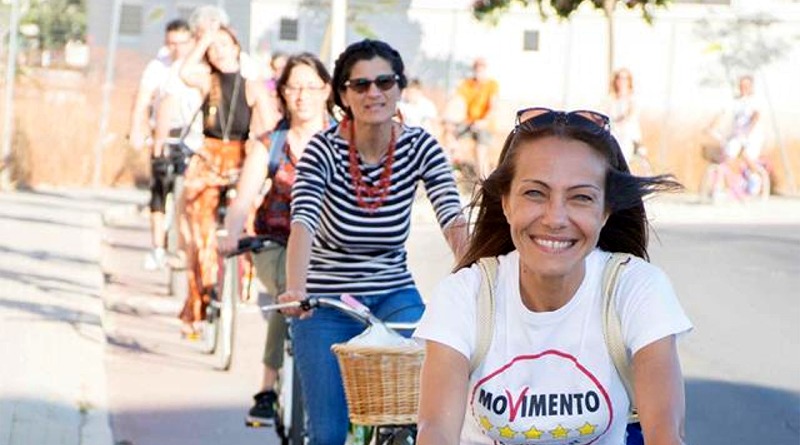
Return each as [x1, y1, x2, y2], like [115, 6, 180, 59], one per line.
[686, 379, 800, 445]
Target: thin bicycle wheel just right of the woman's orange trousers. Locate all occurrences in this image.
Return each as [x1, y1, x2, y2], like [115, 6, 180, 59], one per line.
[217, 257, 240, 371]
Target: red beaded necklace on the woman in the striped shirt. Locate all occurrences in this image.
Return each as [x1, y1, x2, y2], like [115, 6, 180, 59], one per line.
[342, 118, 396, 213]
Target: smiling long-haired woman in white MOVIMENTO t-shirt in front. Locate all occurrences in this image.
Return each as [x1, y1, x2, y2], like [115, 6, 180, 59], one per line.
[414, 108, 692, 445]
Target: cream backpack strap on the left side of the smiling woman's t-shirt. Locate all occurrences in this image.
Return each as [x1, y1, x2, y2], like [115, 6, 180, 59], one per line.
[469, 257, 498, 375]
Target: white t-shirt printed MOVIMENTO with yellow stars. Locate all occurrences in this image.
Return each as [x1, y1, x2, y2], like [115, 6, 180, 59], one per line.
[414, 250, 692, 445]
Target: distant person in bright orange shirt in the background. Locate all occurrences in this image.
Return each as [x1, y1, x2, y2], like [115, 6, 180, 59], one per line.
[456, 57, 498, 177]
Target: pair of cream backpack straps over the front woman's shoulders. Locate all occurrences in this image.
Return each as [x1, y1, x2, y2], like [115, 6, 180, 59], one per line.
[476, 253, 644, 445]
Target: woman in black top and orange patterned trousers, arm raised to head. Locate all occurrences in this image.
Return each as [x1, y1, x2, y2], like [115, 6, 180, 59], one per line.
[180, 21, 277, 339]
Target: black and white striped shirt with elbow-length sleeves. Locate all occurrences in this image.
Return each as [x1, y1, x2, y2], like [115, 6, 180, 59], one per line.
[292, 125, 461, 296]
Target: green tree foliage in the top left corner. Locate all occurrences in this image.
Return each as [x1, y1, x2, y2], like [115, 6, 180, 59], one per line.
[20, 0, 86, 50]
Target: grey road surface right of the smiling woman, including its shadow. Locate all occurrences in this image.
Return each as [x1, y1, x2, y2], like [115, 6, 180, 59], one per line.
[651, 223, 800, 445]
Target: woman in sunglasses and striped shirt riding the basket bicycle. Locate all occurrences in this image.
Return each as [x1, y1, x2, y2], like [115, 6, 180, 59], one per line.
[279, 40, 466, 445]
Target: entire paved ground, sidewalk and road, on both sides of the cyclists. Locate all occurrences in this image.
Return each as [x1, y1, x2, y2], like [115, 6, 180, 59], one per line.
[0, 186, 800, 445]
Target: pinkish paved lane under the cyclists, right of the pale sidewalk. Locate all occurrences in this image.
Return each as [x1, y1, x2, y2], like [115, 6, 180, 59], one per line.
[103, 205, 277, 445]
